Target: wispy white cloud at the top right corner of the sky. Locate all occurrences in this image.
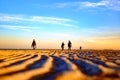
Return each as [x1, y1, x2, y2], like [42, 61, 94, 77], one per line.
[56, 0, 120, 11]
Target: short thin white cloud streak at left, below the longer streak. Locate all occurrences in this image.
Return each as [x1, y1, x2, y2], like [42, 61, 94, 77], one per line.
[0, 25, 32, 31]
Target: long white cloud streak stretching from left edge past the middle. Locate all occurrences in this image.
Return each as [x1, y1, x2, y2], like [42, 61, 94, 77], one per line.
[0, 14, 75, 26]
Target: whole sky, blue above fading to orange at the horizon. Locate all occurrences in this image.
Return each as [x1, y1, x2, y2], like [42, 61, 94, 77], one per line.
[0, 0, 120, 50]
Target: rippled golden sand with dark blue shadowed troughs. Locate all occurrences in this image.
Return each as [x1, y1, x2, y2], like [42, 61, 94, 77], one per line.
[0, 50, 120, 80]
